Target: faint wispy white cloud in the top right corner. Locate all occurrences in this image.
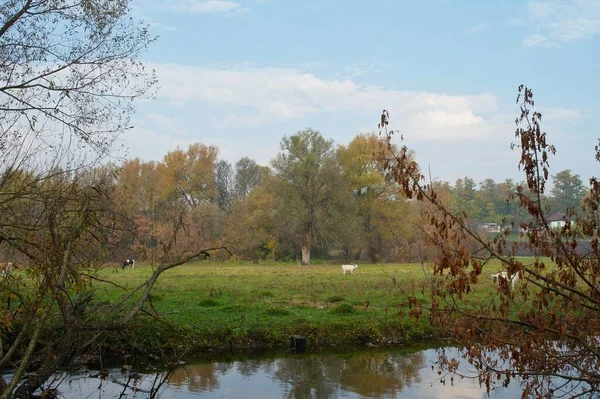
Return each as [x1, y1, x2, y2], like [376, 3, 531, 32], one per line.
[523, 0, 600, 47]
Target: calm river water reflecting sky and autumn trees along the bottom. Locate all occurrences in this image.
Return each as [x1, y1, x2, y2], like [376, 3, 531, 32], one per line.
[50, 350, 521, 399]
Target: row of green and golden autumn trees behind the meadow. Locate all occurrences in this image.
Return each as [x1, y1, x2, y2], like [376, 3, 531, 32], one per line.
[57, 128, 586, 264]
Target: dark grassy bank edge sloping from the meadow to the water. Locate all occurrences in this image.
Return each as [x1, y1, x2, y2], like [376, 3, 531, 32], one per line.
[102, 317, 443, 361]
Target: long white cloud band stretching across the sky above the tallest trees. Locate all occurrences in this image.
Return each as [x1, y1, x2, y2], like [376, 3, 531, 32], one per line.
[151, 64, 497, 139]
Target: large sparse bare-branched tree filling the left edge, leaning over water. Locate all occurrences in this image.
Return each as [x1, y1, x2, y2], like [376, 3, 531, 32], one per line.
[0, 0, 230, 399]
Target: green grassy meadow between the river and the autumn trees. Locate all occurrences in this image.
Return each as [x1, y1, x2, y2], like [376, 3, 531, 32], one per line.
[91, 262, 516, 358]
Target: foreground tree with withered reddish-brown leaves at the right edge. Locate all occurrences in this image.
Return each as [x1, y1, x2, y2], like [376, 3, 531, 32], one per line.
[380, 86, 600, 397]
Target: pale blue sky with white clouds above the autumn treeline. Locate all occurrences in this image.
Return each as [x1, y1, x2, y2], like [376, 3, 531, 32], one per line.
[123, 0, 600, 188]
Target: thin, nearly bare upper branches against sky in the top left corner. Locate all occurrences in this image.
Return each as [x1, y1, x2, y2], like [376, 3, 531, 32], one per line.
[0, 0, 156, 159]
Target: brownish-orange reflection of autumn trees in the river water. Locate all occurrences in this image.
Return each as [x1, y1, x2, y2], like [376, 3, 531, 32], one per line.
[158, 352, 425, 398]
